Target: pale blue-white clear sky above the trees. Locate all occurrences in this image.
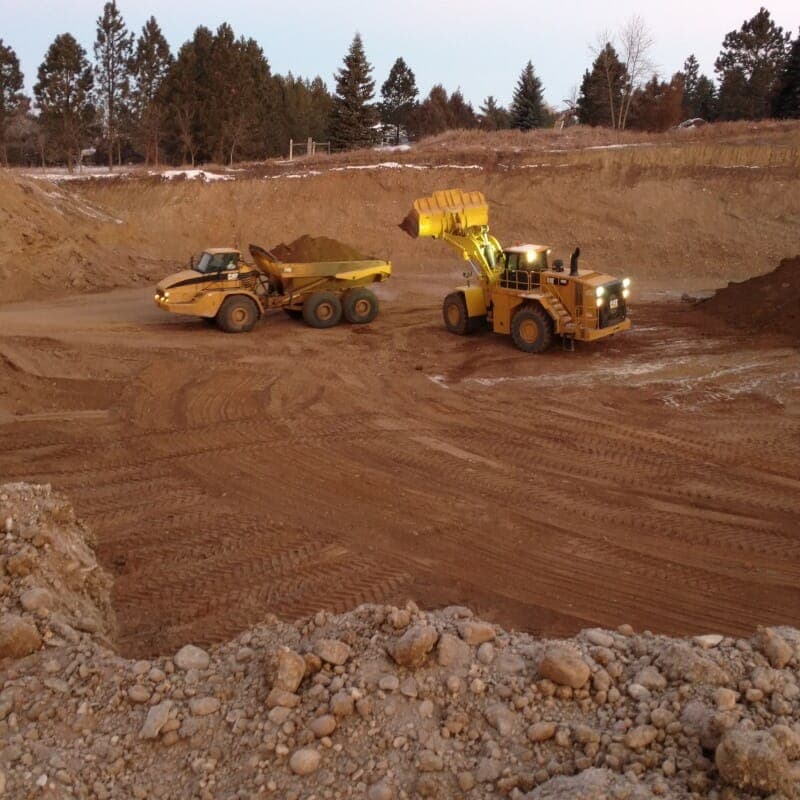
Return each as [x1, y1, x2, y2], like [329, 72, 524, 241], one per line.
[0, 0, 800, 110]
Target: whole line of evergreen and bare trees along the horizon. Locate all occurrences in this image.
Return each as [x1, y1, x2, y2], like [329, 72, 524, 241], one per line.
[0, 0, 800, 168]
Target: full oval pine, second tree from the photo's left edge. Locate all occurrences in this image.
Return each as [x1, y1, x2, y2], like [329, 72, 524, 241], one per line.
[33, 33, 95, 172]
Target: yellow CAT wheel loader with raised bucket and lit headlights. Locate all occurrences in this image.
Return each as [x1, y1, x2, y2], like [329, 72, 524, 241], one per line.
[400, 189, 631, 353]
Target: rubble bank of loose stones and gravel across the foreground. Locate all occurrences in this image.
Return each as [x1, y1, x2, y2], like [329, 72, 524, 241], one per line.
[0, 484, 800, 800]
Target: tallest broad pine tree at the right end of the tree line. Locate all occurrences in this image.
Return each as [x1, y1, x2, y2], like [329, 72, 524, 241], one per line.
[714, 8, 791, 119]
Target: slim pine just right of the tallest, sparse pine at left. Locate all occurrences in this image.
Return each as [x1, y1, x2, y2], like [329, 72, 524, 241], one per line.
[131, 17, 172, 165]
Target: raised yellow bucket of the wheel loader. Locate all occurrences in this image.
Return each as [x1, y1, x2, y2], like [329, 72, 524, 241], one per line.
[400, 189, 489, 239]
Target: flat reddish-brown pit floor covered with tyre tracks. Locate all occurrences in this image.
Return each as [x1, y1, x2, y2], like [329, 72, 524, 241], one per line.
[0, 277, 800, 655]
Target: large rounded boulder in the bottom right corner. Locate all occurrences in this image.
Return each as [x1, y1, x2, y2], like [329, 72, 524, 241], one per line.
[714, 728, 791, 794]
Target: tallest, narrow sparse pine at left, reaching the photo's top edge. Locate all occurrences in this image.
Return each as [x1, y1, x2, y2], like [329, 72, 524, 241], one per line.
[94, 0, 133, 169]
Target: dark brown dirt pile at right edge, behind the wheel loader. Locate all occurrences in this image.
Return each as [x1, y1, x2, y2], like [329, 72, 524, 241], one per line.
[700, 256, 800, 340]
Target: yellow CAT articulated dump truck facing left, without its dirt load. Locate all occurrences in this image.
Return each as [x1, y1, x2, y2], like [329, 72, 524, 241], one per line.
[155, 244, 392, 333]
